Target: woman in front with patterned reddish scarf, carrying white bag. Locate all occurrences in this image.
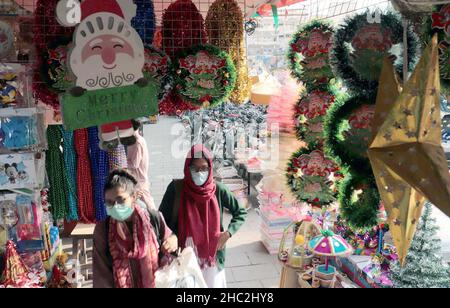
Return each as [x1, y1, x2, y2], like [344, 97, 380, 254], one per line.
[93, 170, 178, 288]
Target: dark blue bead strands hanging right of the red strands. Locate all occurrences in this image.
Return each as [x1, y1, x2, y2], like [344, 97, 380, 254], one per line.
[88, 126, 109, 222]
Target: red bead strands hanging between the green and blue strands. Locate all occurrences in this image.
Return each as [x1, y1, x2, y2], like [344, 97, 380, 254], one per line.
[74, 129, 95, 223]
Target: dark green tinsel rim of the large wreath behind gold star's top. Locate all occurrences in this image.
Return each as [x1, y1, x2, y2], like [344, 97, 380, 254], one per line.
[331, 11, 417, 96]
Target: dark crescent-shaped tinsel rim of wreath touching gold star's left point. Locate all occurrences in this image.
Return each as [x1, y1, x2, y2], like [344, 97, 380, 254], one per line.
[324, 96, 375, 174]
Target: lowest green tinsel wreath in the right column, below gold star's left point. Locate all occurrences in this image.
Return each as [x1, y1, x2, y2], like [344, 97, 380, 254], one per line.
[339, 173, 380, 230]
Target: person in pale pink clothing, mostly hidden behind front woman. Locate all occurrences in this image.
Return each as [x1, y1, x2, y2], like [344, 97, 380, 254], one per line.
[127, 120, 156, 210]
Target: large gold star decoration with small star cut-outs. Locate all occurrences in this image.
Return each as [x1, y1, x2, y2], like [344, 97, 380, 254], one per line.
[369, 36, 450, 265]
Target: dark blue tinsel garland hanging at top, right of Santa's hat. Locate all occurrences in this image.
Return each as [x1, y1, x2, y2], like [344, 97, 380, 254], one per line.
[131, 0, 156, 45]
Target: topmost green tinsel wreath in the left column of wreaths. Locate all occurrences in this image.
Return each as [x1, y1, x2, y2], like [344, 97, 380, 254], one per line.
[287, 20, 334, 88]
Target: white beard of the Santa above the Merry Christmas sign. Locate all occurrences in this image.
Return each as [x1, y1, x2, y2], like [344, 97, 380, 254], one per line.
[75, 53, 144, 90]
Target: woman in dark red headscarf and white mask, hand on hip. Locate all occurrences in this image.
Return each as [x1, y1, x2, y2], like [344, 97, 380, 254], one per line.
[160, 145, 247, 288]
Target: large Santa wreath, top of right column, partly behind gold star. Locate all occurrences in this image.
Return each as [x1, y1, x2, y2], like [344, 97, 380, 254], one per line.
[331, 11, 417, 97]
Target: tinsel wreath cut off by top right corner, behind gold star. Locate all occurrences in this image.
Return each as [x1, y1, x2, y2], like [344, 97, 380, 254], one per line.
[423, 4, 450, 96]
